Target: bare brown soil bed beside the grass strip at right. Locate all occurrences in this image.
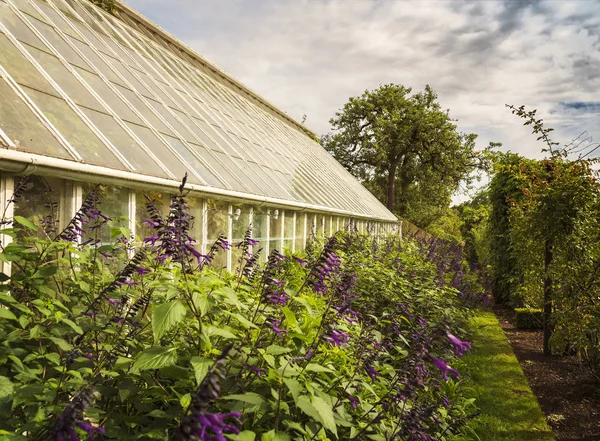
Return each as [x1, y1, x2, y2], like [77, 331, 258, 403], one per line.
[494, 308, 600, 441]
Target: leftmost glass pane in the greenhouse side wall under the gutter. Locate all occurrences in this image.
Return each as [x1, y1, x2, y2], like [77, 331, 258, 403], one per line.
[14, 176, 70, 242]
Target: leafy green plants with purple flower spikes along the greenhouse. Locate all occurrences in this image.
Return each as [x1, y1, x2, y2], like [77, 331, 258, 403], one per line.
[0, 182, 474, 441]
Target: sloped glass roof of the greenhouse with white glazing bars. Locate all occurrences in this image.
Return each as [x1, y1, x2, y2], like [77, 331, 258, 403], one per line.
[0, 0, 396, 220]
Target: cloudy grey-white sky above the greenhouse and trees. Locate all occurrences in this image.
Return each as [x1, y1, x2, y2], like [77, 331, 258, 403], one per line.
[126, 0, 600, 167]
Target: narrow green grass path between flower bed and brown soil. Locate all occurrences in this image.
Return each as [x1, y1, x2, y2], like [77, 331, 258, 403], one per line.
[455, 312, 555, 441]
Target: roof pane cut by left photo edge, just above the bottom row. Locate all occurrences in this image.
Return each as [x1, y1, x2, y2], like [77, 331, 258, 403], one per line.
[0, 34, 58, 95]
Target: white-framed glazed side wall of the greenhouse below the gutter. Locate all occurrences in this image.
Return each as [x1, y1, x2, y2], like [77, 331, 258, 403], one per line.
[0, 173, 398, 270]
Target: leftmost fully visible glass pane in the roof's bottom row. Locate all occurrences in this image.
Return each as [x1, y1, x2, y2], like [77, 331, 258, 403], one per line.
[24, 87, 123, 169]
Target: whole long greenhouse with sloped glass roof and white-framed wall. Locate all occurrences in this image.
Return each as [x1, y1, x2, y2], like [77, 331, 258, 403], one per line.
[0, 0, 397, 268]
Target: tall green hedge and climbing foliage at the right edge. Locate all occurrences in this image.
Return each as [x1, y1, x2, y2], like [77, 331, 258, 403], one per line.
[476, 107, 600, 378]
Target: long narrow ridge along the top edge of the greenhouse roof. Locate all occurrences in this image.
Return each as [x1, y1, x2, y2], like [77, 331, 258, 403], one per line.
[114, 0, 317, 140]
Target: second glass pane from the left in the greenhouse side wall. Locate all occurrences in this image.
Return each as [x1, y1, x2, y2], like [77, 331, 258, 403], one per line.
[82, 182, 129, 244]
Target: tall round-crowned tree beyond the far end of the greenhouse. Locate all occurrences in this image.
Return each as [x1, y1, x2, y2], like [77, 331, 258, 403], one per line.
[321, 84, 478, 226]
